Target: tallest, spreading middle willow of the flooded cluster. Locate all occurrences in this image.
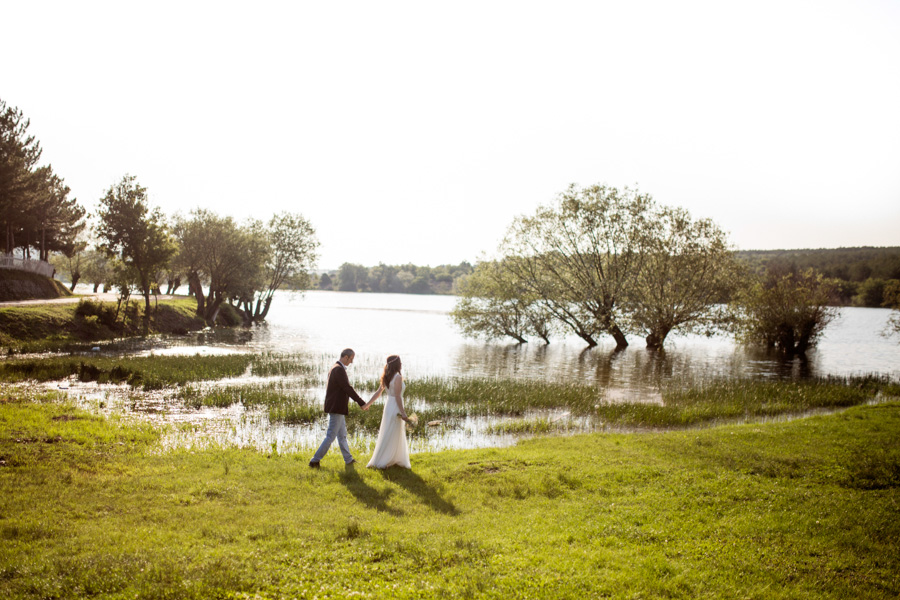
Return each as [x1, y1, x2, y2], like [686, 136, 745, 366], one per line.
[504, 185, 653, 348]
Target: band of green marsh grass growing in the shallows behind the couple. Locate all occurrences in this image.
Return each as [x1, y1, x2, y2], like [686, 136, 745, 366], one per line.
[0, 353, 900, 437]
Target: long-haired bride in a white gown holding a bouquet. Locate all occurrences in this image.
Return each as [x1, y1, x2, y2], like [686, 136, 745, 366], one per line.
[363, 354, 411, 469]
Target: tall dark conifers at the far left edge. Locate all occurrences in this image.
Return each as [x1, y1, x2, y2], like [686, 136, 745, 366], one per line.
[0, 99, 85, 261]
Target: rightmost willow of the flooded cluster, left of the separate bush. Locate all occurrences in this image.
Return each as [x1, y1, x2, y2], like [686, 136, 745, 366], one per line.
[624, 206, 738, 349]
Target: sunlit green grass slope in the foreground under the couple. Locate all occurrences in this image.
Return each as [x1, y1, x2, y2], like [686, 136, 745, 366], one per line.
[0, 385, 900, 599]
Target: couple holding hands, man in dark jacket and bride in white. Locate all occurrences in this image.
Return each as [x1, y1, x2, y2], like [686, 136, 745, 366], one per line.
[309, 348, 411, 469]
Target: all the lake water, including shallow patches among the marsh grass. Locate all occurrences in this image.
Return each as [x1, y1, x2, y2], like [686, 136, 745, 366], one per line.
[51, 291, 900, 452]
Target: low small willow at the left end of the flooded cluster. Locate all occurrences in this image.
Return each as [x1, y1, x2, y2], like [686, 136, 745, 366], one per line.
[450, 258, 555, 344]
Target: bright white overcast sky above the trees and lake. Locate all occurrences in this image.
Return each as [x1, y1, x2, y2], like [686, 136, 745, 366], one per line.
[7, 0, 900, 268]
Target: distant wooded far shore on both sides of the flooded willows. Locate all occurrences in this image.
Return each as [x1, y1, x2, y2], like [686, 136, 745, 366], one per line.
[304, 246, 900, 306]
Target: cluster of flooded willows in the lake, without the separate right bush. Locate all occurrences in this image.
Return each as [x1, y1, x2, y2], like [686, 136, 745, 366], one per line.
[453, 185, 738, 349]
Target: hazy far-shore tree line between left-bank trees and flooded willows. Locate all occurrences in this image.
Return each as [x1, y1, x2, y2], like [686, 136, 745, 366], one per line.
[318, 262, 473, 294]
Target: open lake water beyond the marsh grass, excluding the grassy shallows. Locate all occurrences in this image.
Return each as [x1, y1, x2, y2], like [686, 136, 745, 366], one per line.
[169, 291, 900, 394]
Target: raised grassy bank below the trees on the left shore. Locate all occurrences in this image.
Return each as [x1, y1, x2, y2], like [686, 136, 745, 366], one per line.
[0, 298, 240, 352]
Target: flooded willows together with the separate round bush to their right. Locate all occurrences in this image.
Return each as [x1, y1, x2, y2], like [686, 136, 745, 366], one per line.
[452, 185, 856, 354]
